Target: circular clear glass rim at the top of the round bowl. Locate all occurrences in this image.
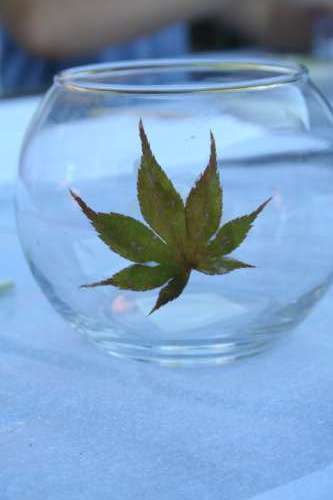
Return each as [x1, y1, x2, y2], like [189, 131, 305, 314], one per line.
[54, 57, 309, 95]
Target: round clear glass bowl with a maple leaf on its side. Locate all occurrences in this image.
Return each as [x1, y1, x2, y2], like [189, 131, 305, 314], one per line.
[17, 59, 333, 365]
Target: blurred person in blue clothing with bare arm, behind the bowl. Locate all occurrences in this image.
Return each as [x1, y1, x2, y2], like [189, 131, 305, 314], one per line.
[0, 0, 204, 93]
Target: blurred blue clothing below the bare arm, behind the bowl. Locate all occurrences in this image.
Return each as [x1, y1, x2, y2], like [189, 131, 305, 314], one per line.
[0, 24, 188, 93]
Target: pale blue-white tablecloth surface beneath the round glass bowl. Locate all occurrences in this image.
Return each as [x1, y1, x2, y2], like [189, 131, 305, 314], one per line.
[0, 95, 333, 500]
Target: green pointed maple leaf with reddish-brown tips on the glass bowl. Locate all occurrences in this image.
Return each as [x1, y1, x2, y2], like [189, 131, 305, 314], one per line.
[71, 121, 270, 313]
